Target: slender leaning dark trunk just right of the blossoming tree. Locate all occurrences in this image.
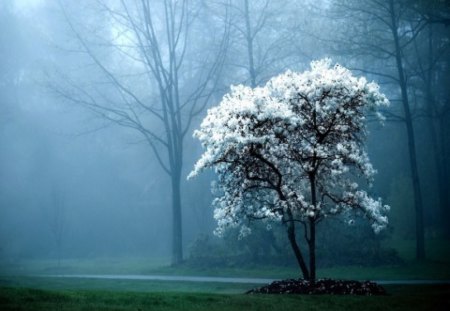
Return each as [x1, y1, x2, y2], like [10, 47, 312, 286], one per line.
[389, 0, 425, 260]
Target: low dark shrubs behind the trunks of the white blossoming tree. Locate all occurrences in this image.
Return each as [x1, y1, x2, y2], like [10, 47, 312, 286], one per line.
[185, 218, 404, 269]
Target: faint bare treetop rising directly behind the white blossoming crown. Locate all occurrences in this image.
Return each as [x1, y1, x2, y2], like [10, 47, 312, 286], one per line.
[225, 0, 298, 87]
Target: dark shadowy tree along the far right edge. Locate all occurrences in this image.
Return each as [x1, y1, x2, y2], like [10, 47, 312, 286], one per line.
[408, 20, 450, 236]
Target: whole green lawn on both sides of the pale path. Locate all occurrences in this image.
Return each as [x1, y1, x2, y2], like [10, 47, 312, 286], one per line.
[0, 239, 450, 311]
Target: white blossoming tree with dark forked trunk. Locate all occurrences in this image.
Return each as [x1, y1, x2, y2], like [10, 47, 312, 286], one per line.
[189, 59, 389, 282]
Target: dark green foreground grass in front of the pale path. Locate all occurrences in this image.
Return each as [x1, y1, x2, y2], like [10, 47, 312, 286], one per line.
[0, 286, 450, 311]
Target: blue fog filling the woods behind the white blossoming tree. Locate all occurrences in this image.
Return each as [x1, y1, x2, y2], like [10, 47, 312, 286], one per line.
[0, 0, 450, 272]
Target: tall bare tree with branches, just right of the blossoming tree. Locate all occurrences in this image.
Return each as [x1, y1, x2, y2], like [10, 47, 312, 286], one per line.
[328, 0, 427, 259]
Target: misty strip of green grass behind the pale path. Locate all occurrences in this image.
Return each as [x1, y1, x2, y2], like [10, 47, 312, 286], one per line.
[0, 256, 450, 280]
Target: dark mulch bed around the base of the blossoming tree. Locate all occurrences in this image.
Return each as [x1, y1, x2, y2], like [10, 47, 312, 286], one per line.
[246, 279, 386, 296]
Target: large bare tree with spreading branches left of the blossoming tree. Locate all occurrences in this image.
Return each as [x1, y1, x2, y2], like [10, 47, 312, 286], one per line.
[54, 0, 229, 264]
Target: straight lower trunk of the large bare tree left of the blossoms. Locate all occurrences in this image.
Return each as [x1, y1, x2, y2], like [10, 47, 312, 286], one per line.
[171, 168, 183, 265]
